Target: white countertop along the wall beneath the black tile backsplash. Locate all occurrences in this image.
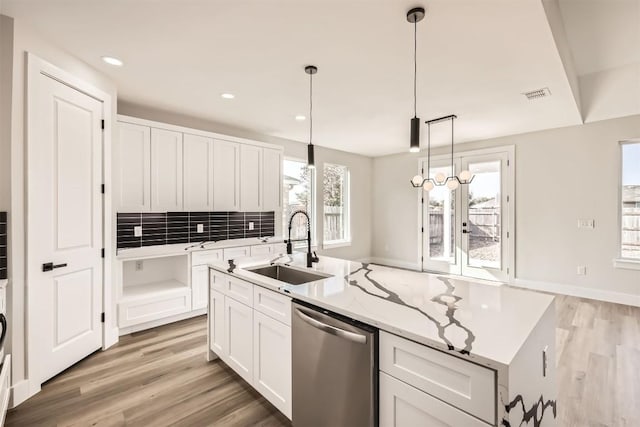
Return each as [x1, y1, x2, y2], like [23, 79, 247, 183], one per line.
[116, 236, 284, 260]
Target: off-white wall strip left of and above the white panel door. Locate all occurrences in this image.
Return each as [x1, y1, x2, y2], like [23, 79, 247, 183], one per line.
[2, 16, 116, 402]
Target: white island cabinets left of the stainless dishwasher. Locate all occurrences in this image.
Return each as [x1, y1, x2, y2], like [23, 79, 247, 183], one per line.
[208, 270, 291, 419]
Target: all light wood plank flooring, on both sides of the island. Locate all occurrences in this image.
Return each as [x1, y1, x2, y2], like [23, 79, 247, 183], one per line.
[6, 296, 640, 427]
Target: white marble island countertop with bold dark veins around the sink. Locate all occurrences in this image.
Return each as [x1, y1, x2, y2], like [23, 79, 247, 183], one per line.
[210, 253, 554, 369]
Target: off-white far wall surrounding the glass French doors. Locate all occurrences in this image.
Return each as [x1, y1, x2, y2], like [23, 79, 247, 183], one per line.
[372, 116, 640, 304]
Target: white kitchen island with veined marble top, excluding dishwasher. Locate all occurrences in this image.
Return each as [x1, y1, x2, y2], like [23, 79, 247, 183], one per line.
[209, 253, 556, 426]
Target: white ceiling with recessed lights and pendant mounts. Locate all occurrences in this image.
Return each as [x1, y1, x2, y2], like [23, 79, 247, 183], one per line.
[2, 0, 638, 156]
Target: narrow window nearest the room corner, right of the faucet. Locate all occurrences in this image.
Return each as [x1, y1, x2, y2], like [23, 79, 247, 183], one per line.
[322, 163, 351, 247]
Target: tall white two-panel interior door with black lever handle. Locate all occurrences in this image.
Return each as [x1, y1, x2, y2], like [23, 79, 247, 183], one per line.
[27, 74, 103, 382]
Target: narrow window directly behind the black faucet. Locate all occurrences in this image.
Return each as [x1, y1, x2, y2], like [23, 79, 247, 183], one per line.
[282, 159, 315, 247]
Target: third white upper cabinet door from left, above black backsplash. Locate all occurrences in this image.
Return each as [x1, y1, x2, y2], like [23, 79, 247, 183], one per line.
[182, 133, 213, 212]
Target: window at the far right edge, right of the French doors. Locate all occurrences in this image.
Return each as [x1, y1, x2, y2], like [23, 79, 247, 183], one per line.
[620, 141, 640, 261]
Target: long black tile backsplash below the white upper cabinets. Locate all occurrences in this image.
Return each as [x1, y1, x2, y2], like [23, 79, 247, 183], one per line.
[117, 212, 275, 249]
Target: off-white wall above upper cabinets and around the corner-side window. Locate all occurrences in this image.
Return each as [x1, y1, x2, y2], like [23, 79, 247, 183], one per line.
[118, 100, 373, 259]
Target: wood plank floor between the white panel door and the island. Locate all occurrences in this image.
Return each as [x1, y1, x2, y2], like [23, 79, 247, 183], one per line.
[6, 316, 291, 427]
